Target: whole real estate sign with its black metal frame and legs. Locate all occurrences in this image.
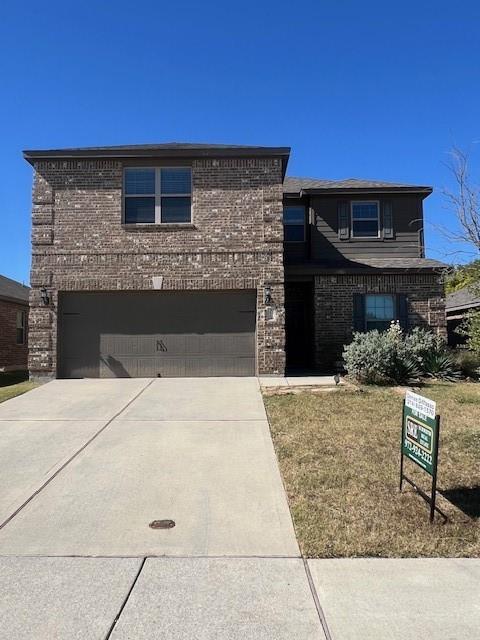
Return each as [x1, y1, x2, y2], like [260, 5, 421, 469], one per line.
[400, 391, 445, 522]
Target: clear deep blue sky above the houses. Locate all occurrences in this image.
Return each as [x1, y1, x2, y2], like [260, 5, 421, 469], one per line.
[0, 0, 480, 282]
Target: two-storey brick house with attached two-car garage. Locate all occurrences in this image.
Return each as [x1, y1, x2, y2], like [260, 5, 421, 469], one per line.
[24, 143, 446, 379]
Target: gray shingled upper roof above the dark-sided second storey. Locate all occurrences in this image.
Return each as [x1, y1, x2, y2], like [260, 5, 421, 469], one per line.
[283, 176, 432, 195]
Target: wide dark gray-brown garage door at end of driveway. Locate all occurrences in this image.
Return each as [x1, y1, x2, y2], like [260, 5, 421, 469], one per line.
[59, 291, 256, 378]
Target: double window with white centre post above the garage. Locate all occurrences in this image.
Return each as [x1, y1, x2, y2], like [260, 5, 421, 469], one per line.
[124, 167, 192, 224]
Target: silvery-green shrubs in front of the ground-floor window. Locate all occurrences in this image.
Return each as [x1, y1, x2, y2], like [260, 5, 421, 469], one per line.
[343, 322, 460, 384]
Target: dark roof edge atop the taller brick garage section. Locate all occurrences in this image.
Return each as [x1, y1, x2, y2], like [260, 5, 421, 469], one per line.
[23, 142, 290, 162]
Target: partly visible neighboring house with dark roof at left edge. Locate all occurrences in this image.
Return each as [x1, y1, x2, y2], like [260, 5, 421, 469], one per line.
[0, 276, 30, 372]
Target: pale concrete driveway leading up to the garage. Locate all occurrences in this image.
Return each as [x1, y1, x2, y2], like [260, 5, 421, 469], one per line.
[0, 378, 299, 557]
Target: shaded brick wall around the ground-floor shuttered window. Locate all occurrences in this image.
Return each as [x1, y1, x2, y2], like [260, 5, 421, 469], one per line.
[314, 272, 447, 371]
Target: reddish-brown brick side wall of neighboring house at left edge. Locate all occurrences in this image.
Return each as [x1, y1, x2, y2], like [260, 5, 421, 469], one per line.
[0, 300, 28, 371]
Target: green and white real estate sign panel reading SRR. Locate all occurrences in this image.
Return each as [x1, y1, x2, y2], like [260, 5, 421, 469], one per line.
[402, 391, 438, 476]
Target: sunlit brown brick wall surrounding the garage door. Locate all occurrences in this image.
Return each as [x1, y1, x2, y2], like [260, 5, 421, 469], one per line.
[29, 158, 285, 379]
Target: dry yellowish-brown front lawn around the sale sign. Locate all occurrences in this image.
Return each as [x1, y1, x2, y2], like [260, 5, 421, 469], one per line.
[265, 383, 480, 557]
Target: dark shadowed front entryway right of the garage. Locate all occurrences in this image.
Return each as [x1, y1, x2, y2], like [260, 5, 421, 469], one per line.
[285, 282, 313, 372]
